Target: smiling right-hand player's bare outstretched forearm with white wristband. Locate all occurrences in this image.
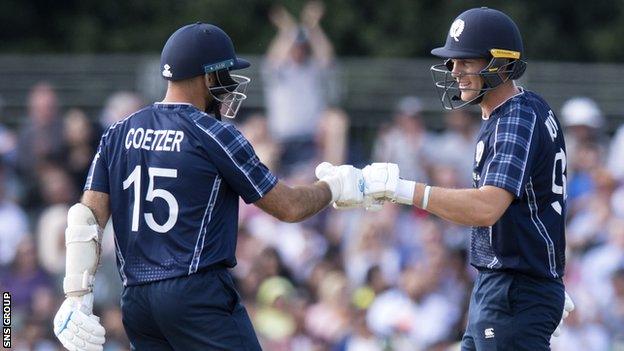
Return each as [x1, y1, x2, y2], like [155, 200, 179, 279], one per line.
[414, 183, 500, 226]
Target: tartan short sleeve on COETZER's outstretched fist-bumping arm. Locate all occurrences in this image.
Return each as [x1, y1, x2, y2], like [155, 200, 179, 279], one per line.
[197, 122, 277, 204]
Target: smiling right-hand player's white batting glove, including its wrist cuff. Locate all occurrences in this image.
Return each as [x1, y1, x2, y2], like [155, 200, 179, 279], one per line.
[362, 163, 416, 205]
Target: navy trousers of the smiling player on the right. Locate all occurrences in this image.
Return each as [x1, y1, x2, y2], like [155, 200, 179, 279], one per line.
[461, 271, 564, 351]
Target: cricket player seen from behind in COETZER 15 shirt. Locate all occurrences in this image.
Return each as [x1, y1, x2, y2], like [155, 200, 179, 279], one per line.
[54, 23, 364, 351]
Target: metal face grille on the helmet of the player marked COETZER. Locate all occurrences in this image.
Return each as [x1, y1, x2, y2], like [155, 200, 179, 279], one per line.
[208, 70, 251, 118]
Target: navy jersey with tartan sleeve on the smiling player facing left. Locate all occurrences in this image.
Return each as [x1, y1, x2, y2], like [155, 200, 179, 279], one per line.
[470, 90, 566, 278]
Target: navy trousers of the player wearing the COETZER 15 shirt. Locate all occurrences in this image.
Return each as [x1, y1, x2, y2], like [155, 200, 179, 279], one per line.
[121, 268, 261, 351]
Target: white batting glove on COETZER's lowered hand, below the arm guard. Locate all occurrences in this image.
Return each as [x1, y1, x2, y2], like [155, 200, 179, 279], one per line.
[54, 293, 106, 351]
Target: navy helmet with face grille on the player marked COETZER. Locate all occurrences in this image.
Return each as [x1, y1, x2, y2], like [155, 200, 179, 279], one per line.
[160, 22, 250, 119]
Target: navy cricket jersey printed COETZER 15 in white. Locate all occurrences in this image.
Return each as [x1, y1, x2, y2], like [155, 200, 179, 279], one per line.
[84, 103, 277, 286]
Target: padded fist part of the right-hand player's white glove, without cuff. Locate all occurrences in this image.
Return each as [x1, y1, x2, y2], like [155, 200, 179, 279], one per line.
[362, 163, 399, 202]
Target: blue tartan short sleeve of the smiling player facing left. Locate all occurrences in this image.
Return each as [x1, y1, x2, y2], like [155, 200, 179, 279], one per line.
[482, 110, 537, 198]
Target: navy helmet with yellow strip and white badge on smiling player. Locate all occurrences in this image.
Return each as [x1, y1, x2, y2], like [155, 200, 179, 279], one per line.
[431, 7, 526, 110]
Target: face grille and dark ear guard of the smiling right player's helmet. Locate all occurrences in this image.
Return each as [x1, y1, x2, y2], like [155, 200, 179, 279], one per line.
[430, 51, 526, 110]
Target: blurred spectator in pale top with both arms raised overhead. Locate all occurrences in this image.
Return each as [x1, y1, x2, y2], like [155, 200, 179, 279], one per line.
[262, 1, 334, 169]
